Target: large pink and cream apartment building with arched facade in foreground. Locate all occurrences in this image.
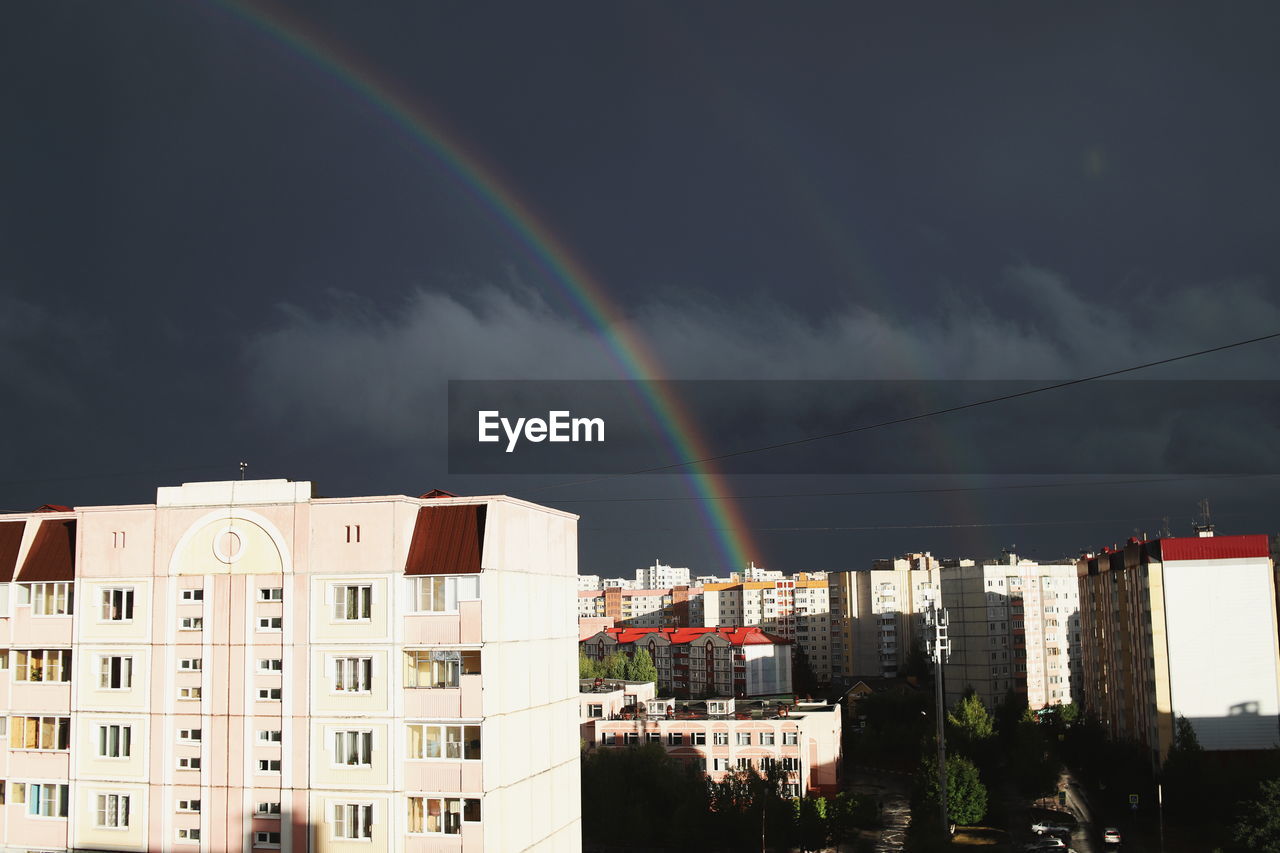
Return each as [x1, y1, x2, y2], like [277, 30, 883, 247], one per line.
[0, 480, 581, 853]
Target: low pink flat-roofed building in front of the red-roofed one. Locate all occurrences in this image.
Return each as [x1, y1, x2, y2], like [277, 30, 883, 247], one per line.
[584, 698, 841, 797]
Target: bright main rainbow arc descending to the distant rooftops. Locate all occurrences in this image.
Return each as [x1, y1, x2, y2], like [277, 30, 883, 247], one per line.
[218, 0, 762, 574]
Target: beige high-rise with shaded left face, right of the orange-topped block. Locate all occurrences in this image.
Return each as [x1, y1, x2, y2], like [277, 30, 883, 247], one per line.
[827, 552, 947, 683]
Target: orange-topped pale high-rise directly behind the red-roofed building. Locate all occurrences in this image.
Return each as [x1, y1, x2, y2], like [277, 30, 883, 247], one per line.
[703, 570, 832, 683]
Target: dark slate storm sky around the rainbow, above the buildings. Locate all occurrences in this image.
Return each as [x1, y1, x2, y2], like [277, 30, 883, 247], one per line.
[0, 0, 1280, 574]
